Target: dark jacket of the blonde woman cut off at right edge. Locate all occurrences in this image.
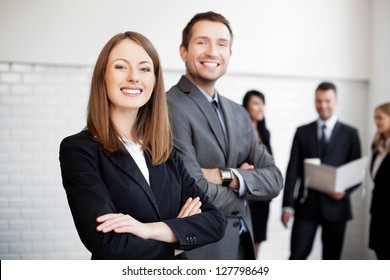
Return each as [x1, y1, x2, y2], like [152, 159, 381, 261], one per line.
[369, 154, 390, 256]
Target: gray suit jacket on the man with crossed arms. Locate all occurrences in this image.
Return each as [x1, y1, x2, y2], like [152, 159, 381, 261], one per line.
[167, 76, 283, 259]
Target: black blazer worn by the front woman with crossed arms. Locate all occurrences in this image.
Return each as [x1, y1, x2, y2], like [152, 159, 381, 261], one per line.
[60, 131, 226, 259]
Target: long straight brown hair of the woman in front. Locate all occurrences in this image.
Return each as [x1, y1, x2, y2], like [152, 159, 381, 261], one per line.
[86, 31, 172, 165]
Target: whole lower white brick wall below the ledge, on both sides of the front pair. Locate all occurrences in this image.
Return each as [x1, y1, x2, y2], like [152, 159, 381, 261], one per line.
[0, 62, 372, 259]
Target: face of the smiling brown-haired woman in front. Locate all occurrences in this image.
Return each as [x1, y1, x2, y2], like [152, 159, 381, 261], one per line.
[105, 39, 156, 112]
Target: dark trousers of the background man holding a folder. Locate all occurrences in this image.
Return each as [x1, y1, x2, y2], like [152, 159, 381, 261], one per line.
[289, 218, 346, 260]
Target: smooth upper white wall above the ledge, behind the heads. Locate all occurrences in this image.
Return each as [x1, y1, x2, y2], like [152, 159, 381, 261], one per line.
[0, 0, 370, 80]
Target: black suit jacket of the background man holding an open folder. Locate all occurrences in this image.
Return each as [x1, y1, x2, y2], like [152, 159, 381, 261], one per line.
[283, 121, 361, 222]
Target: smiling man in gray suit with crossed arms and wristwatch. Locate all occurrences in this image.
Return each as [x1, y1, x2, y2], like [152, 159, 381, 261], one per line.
[167, 12, 283, 259]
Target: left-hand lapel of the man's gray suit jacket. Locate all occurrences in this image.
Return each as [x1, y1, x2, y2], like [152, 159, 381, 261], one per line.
[178, 76, 227, 157]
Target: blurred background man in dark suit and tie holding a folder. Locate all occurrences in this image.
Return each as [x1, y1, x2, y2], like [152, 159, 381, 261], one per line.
[282, 82, 361, 260]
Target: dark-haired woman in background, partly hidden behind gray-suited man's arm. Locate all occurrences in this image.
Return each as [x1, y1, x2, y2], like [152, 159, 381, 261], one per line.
[242, 90, 272, 256]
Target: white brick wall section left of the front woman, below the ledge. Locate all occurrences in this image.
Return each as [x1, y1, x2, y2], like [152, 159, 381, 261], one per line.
[0, 62, 91, 259]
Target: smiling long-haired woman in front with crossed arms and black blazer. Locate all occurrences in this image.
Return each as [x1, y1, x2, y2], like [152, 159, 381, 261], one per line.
[60, 32, 226, 259]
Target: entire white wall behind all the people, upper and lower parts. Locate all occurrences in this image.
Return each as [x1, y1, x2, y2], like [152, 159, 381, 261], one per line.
[0, 0, 390, 259]
